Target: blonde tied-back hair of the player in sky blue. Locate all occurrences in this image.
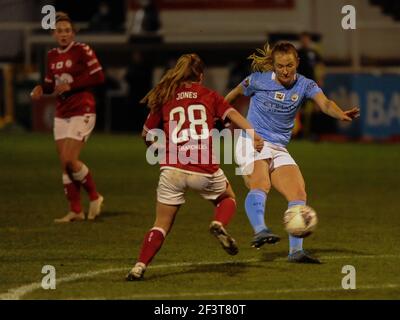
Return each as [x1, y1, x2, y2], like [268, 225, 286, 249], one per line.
[247, 42, 298, 72]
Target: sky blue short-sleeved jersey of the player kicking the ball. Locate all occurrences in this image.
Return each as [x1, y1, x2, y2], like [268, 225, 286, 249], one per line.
[241, 72, 322, 147]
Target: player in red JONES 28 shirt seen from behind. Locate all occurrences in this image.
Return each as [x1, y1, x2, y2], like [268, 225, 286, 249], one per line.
[126, 54, 263, 281]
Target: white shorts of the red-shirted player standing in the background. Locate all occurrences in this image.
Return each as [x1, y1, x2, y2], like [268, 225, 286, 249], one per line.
[54, 113, 96, 142]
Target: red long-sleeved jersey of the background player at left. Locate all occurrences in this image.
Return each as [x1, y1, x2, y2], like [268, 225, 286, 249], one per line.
[44, 42, 104, 118]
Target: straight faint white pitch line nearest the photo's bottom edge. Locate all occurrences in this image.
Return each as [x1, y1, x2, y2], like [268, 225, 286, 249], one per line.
[76, 283, 400, 300]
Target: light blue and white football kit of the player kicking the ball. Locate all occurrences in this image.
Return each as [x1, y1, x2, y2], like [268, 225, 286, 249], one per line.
[241, 72, 322, 254]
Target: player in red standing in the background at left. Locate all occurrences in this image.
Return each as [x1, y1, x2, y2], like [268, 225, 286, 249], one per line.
[31, 13, 104, 222]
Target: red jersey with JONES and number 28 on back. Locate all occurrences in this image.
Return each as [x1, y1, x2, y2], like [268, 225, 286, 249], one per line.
[143, 83, 233, 175]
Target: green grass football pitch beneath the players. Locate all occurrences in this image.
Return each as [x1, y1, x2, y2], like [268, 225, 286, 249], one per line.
[0, 134, 400, 299]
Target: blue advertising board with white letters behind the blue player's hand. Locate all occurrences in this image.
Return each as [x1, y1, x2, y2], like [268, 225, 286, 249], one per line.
[324, 73, 400, 139]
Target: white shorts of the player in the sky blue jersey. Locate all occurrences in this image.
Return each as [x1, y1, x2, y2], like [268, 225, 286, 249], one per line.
[235, 135, 297, 175]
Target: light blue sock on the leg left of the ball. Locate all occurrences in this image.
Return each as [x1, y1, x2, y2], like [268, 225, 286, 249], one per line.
[244, 189, 267, 233]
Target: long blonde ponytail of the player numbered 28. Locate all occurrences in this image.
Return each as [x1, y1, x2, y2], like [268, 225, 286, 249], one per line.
[140, 53, 204, 113]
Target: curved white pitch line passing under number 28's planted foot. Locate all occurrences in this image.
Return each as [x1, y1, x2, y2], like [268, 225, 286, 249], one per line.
[0, 255, 400, 300]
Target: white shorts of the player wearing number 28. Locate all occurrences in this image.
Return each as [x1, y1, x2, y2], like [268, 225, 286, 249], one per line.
[157, 168, 228, 205]
